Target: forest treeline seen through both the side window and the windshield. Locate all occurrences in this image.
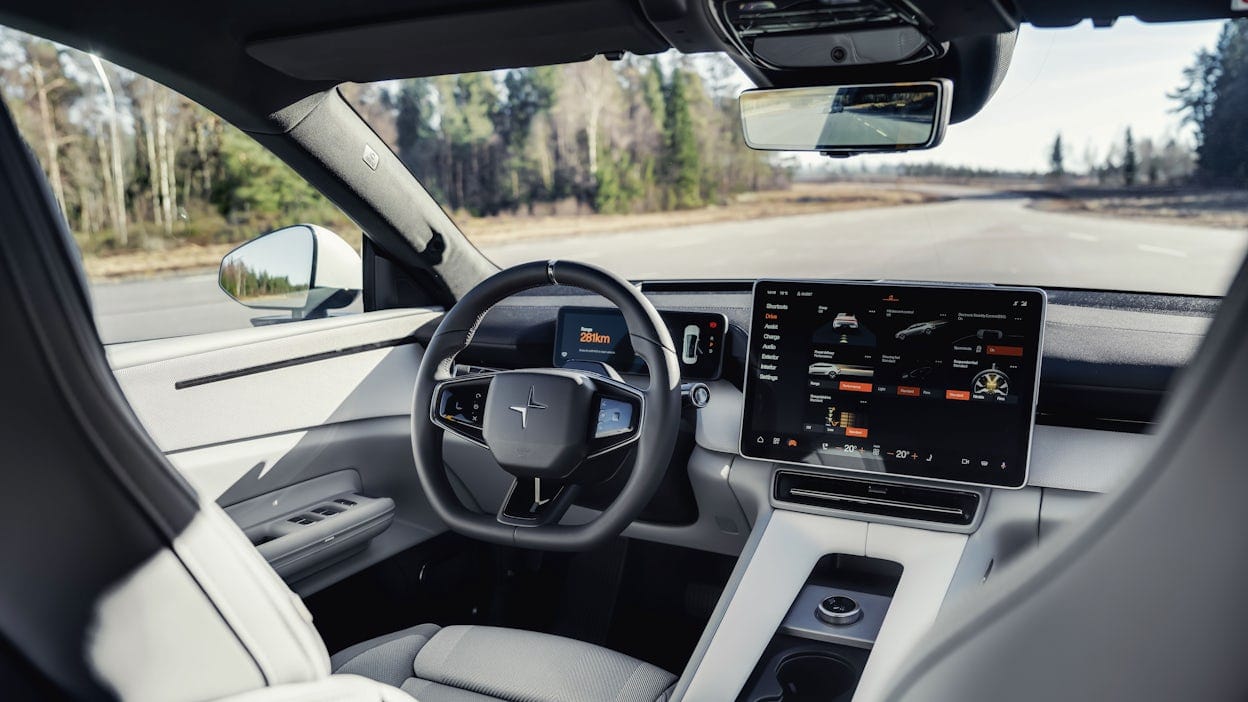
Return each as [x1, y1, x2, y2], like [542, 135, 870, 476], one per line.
[0, 27, 786, 254]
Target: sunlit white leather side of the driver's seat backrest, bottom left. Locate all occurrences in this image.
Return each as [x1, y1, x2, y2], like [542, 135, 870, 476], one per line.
[87, 502, 329, 702]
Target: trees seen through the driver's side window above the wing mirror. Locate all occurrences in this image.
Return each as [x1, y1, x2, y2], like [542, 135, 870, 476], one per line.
[0, 27, 349, 254]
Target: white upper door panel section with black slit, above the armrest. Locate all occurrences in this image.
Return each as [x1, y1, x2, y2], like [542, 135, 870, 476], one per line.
[109, 310, 438, 453]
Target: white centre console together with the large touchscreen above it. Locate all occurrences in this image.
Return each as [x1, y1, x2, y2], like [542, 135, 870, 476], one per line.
[676, 281, 1046, 702]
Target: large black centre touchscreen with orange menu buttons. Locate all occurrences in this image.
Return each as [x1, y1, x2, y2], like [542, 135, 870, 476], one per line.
[741, 281, 1045, 487]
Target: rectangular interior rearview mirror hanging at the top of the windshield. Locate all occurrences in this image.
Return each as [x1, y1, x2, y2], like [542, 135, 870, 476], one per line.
[740, 80, 952, 156]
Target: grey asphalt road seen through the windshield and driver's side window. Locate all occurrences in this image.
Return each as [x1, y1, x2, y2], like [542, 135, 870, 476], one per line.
[92, 189, 1248, 344]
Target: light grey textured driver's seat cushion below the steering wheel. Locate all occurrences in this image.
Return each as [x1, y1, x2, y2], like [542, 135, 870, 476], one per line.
[332, 625, 676, 702]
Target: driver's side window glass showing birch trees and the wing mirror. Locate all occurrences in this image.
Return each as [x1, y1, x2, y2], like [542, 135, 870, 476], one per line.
[0, 26, 362, 345]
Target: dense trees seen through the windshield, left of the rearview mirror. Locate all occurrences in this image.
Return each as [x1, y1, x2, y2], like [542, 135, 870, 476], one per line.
[344, 56, 786, 216]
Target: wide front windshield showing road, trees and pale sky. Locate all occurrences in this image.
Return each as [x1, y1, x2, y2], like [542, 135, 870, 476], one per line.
[344, 20, 1248, 295]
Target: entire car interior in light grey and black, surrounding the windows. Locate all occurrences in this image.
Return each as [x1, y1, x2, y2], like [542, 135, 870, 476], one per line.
[0, 0, 1248, 702]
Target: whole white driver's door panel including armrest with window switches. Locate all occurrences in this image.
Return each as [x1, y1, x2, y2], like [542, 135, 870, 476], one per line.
[109, 310, 446, 595]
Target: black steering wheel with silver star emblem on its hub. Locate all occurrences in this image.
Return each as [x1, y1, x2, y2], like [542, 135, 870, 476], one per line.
[412, 261, 680, 551]
